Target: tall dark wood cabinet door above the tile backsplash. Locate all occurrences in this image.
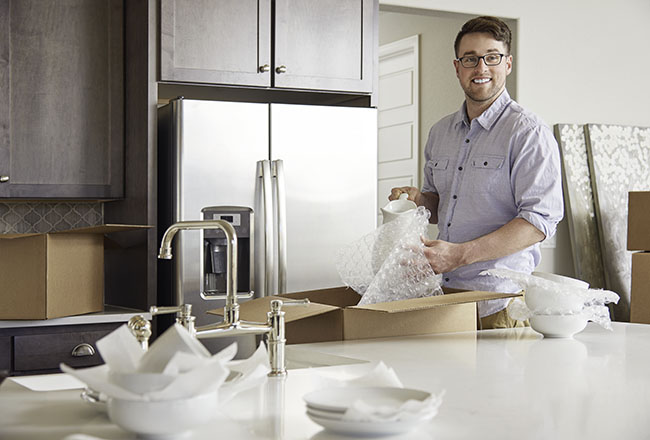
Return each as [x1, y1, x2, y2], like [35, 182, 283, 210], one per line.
[0, 0, 124, 198]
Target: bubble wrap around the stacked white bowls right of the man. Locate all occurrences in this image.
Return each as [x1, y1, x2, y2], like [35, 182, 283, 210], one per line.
[480, 269, 619, 330]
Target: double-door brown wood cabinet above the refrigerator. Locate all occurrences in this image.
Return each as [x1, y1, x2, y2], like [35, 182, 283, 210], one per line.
[160, 0, 377, 94]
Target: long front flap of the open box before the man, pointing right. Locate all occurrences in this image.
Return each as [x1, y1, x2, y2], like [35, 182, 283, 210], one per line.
[349, 290, 521, 313]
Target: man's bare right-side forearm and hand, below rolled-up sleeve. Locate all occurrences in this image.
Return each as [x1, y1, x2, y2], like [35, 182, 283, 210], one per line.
[422, 217, 545, 273]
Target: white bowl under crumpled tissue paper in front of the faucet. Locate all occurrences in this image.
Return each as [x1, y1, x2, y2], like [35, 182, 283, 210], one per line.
[108, 392, 219, 438]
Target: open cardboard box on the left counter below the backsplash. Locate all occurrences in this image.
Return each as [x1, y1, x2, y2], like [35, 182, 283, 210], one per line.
[0, 225, 149, 319]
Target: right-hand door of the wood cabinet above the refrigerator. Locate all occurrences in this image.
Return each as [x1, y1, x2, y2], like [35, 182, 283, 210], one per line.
[274, 0, 375, 93]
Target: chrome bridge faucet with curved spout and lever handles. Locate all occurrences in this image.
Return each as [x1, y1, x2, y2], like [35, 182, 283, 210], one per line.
[142, 220, 309, 376]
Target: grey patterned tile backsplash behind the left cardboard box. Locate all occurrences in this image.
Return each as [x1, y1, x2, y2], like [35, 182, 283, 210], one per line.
[0, 201, 104, 234]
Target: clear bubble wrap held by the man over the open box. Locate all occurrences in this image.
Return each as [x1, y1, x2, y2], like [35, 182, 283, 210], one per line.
[337, 207, 442, 305]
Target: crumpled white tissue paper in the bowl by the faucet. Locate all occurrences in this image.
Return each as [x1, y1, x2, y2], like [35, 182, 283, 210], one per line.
[61, 324, 270, 402]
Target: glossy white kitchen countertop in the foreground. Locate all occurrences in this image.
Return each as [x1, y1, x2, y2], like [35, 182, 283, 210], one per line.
[0, 323, 650, 440]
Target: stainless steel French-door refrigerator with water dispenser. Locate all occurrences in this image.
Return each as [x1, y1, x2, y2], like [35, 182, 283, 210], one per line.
[158, 99, 377, 351]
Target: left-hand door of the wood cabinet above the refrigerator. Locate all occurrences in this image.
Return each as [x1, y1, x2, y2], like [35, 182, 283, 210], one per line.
[160, 0, 271, 87]
